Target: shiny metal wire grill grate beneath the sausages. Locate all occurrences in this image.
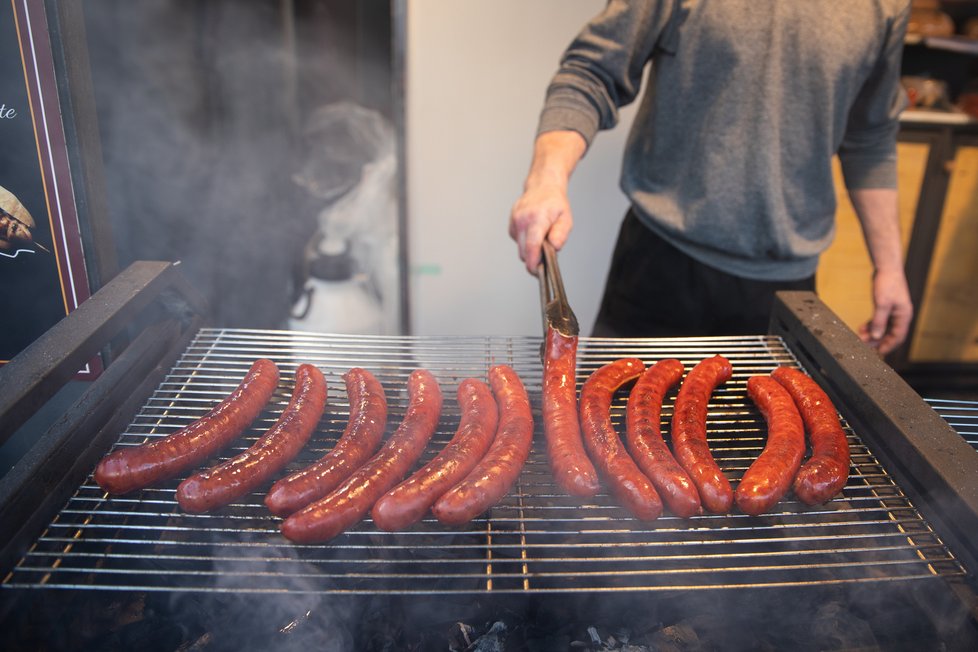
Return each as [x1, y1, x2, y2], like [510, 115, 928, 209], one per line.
[4, 330, 964, 594]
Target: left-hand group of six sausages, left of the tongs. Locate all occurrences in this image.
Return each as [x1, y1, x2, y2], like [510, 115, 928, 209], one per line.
[94, 359, 533, 543]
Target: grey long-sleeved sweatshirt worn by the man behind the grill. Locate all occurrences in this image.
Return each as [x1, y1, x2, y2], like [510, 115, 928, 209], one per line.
[539, 0, 910, 280]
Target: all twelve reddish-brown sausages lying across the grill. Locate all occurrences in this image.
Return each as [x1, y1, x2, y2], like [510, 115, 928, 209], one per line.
[95, 344, 849, 543]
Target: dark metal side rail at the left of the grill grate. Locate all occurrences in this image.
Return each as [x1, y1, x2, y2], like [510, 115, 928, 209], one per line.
[0, 261, 207, 575]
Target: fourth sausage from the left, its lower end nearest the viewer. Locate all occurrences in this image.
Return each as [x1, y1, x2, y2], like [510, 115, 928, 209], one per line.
[282, 369, 442, 543]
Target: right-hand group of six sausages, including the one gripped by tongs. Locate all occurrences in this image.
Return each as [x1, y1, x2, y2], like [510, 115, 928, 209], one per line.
[543, 329, 849, 520]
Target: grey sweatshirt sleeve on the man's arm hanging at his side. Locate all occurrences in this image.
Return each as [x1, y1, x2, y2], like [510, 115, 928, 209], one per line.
[839, 3, 910, 190]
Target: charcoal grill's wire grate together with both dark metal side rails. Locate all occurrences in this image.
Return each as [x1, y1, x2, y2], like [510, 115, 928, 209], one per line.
[0, 263, 978, 648]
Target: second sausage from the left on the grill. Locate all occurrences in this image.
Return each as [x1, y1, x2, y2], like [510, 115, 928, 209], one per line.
[177, 364, 326, 513]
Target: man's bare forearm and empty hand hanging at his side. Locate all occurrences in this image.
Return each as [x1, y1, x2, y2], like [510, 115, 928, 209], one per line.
[849, 188, 913, 355]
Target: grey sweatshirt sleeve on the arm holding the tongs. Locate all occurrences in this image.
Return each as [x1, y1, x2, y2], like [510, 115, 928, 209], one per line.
[537, 0, 678, 145]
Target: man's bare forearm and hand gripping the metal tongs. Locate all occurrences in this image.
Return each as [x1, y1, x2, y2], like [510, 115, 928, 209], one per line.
[509, 131, 587, 274]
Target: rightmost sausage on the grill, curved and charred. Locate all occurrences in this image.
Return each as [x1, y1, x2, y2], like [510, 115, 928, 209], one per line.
[771, 367, 849, 505]
